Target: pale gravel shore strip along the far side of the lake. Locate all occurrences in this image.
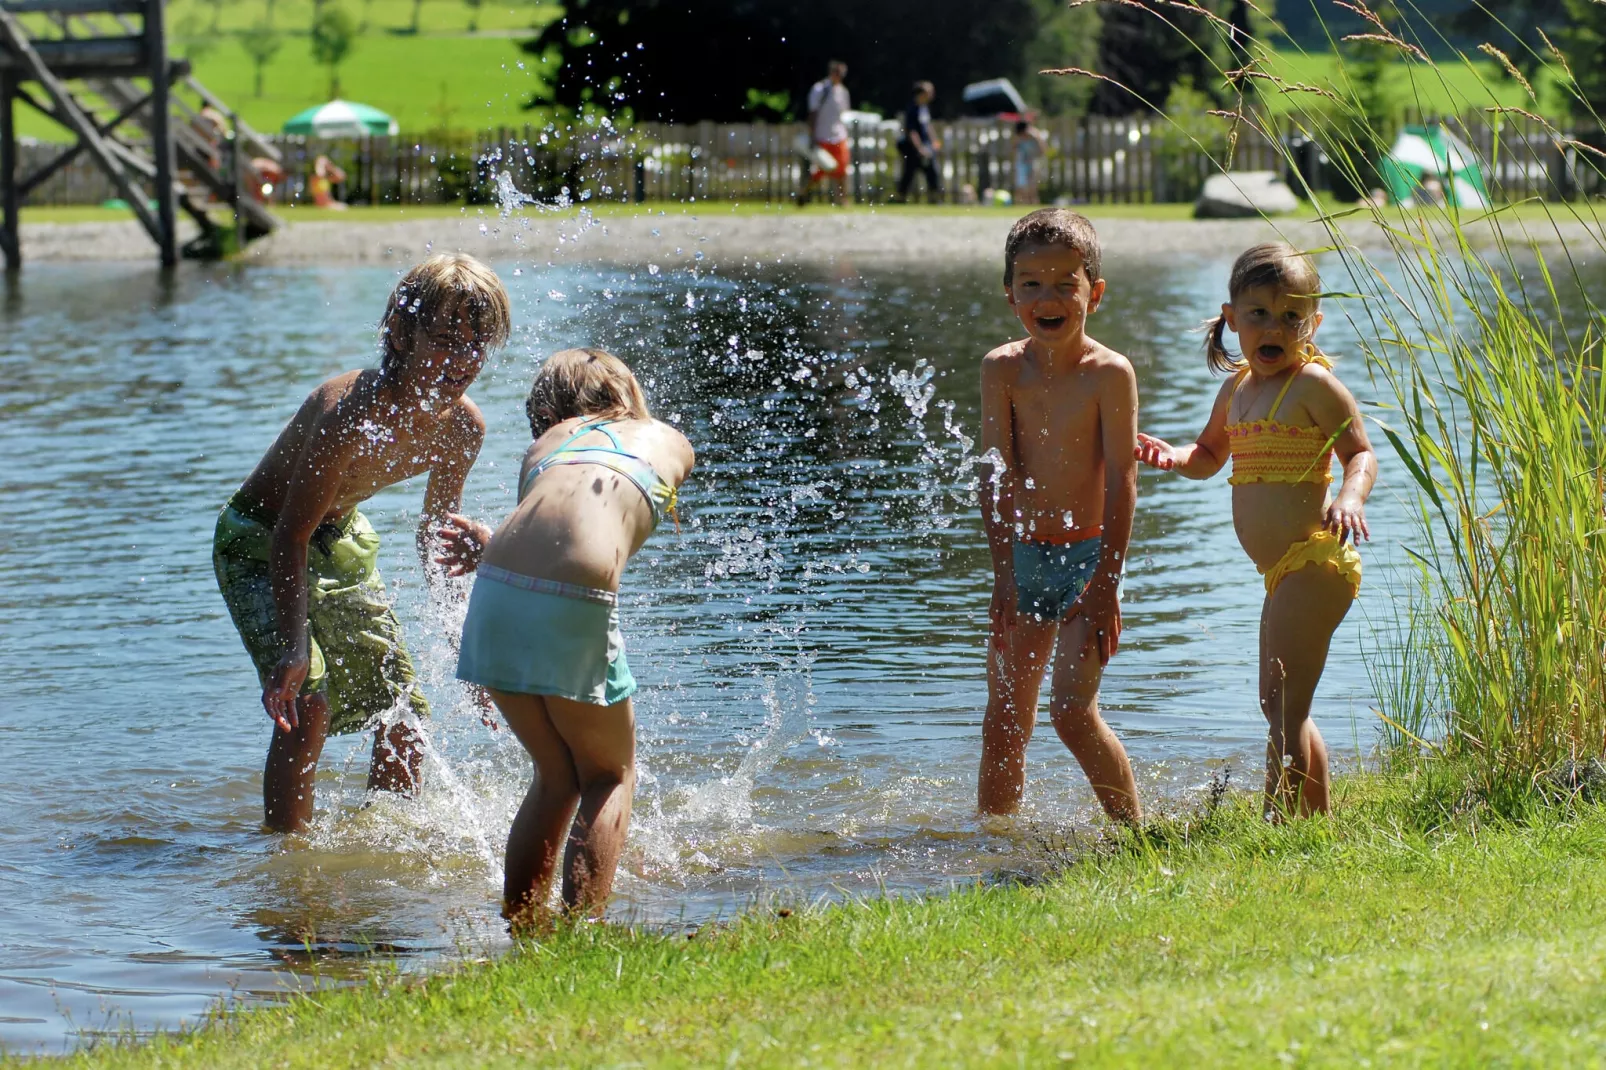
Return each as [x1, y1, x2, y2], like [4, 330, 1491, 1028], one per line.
[22, 206, 1606, 270]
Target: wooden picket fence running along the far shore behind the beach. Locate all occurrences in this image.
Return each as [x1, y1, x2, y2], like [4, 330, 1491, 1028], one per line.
[21, 112, 1606, 204]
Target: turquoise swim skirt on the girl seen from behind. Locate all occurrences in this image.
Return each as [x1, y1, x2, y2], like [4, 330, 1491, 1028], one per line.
[458, 566, 636, 705]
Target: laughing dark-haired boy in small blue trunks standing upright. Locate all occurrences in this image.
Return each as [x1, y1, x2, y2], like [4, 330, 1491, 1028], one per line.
[978, 209, 1142, 823]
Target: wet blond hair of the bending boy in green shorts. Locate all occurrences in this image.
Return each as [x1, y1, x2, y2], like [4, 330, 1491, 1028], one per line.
[379, 252, 512, 371]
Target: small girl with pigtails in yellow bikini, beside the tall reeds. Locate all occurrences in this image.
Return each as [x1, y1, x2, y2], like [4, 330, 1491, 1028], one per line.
[1137, 243, 1378, 818]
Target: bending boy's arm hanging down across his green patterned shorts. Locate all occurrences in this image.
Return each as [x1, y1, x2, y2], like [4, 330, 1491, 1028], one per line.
[262, 415, 357, 731]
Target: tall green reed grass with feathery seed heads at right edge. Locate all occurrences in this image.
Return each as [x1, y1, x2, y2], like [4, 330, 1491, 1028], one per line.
[1076, 0, 1606, 800]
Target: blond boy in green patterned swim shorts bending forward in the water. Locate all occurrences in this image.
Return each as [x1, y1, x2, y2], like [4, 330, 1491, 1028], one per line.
[212, 255, 509, 832]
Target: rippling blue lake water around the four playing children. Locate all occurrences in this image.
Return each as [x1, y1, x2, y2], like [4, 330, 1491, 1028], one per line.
[0, 224, 1445, 1051]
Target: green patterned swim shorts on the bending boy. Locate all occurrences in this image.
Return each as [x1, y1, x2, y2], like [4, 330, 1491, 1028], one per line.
[212, 500, 429, 734]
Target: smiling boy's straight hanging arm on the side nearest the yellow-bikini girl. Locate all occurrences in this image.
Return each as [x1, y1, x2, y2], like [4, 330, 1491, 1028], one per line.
[1076, 360, 1137, 665]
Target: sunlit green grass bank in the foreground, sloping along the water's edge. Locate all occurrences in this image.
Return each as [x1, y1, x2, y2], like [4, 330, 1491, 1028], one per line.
[31, 778, 1606, 1067]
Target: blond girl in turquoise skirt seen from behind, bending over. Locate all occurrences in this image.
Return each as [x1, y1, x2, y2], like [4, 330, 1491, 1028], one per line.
[440, 349, 694, 933]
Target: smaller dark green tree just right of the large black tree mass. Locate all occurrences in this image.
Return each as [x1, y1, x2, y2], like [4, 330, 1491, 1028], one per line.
[1092, 0, 1237, 116]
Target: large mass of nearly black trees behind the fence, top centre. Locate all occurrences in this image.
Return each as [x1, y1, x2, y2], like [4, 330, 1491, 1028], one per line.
[524, 0, 1097, 122]
